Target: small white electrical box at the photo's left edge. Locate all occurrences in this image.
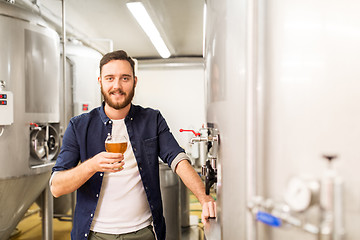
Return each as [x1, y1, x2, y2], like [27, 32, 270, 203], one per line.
[0, 91, 14, 125]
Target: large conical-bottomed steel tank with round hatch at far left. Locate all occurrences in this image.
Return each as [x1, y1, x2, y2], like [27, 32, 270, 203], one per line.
[0, 2, 60, 239]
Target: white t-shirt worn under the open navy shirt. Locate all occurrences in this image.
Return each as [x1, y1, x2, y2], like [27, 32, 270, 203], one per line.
[90, 119, 151, 234]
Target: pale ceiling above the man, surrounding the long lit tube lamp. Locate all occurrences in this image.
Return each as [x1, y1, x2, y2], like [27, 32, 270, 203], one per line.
[38, 0, 205, 59]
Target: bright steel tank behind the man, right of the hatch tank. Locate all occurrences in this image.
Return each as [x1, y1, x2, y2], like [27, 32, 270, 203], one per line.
[54, 39, 102, 219]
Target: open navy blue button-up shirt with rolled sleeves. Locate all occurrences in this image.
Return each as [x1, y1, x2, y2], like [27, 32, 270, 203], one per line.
[53, 103, 184, 240]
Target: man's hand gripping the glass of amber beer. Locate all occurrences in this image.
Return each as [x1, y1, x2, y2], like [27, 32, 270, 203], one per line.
[87, 152, 125, 172]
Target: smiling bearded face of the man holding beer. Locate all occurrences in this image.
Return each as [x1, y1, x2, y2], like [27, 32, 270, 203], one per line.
[98, 60, 137, 110]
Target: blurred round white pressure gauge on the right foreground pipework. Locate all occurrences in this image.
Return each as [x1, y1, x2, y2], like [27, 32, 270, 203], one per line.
[284, 177, 319, 212]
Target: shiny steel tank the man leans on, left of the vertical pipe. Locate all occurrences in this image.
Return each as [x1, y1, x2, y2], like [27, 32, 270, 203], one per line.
[205, 0, 252, 239]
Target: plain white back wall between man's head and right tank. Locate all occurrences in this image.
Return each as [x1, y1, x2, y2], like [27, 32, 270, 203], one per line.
[133, 59, 205, 161]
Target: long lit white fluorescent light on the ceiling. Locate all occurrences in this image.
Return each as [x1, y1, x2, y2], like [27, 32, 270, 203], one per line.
[126, 2, 171, 58]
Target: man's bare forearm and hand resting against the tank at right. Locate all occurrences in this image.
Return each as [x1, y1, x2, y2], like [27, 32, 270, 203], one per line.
[175, 160, 216, 224]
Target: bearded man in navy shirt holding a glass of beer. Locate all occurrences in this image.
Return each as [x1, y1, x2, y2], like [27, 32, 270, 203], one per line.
[51, 51, 216, 240]
